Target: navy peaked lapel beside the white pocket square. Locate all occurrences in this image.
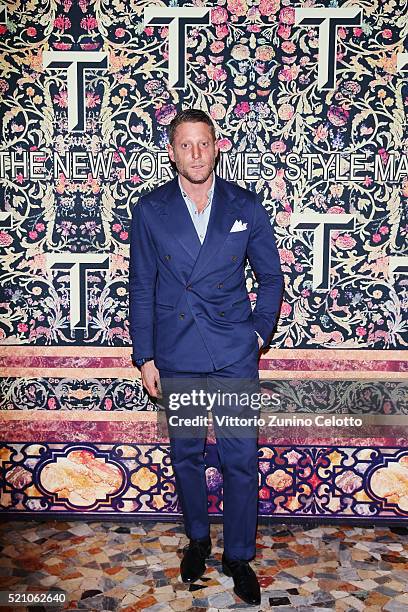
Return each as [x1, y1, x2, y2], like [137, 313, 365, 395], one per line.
[189, 176, 244, 282]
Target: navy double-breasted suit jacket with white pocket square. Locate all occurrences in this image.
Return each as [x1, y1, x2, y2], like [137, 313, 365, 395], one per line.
[129, 176, 283, 372]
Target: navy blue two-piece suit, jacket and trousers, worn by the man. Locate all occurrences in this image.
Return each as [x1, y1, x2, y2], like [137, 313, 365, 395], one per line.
[129, 177, 283, 559]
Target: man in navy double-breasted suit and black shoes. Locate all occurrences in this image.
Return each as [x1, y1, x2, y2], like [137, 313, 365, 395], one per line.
[129, 109, 283, 605]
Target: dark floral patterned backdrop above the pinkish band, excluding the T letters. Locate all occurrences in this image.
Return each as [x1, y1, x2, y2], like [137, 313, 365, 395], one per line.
[0, 0, 408, 349]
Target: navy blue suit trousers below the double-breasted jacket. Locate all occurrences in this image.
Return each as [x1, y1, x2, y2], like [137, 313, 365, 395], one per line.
[160, 334, 260, 560]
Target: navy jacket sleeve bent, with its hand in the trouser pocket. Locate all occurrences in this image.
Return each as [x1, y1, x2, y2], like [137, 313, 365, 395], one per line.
[247, 199, 284, 348]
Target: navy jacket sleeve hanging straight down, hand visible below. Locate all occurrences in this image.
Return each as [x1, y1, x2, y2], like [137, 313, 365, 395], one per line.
[129, 198, 157, 359]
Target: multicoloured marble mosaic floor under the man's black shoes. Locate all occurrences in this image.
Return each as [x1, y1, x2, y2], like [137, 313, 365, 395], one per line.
[0, 521, 408, 612]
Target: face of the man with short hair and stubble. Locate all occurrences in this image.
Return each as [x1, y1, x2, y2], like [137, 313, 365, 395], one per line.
[167, 121, 218, 184]
